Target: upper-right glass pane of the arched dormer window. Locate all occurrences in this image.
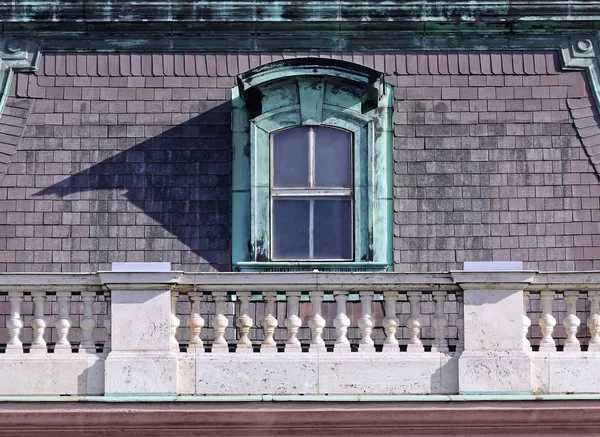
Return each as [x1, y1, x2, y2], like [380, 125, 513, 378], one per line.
[315, 128, 352, 188]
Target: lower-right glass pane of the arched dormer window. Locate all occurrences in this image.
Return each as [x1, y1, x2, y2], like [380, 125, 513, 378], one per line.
[314, 198, 352, 259]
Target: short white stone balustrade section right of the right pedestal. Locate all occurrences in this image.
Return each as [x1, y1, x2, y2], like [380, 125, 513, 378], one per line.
[525, 272, 600, 393]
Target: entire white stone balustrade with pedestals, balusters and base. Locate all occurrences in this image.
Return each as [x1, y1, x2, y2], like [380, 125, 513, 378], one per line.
[0, 271, 600, 396]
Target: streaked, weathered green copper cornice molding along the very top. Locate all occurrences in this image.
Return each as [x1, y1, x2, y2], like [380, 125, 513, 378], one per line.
[0, 0, 600, 23]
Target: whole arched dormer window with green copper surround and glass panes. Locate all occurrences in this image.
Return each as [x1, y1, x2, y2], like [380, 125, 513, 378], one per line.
[232, 58, 393, 271]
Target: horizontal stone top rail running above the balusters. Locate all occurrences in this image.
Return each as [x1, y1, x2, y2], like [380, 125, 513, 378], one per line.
[0, 271, 600, 293]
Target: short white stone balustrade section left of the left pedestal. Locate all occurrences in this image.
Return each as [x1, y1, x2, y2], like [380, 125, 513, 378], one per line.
[0, 274, 110, 396]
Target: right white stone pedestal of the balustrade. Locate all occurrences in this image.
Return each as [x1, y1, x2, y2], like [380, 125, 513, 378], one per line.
[452, 271, 535, 394]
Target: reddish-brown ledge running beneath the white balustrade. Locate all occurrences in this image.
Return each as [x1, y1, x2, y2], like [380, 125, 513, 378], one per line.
[0, 401, 600, 437]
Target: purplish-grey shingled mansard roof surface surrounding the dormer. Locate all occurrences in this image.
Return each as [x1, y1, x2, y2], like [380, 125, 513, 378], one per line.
[0, 52, 600, 271]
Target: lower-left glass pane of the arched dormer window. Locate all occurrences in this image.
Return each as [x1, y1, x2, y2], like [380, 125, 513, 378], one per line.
[272, 199, 310, 259]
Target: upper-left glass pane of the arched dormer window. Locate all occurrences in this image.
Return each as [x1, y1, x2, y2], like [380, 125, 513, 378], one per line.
[273, 127, 309, 187]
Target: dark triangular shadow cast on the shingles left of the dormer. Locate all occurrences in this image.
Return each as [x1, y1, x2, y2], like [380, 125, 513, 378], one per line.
[35, 103, 231, 271]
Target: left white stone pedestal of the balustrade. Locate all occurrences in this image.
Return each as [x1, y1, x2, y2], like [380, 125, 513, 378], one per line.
[99, 271, 182, 395]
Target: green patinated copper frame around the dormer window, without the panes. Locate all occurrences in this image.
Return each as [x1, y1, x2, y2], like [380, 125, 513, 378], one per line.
[232, 58, 393, 271]
